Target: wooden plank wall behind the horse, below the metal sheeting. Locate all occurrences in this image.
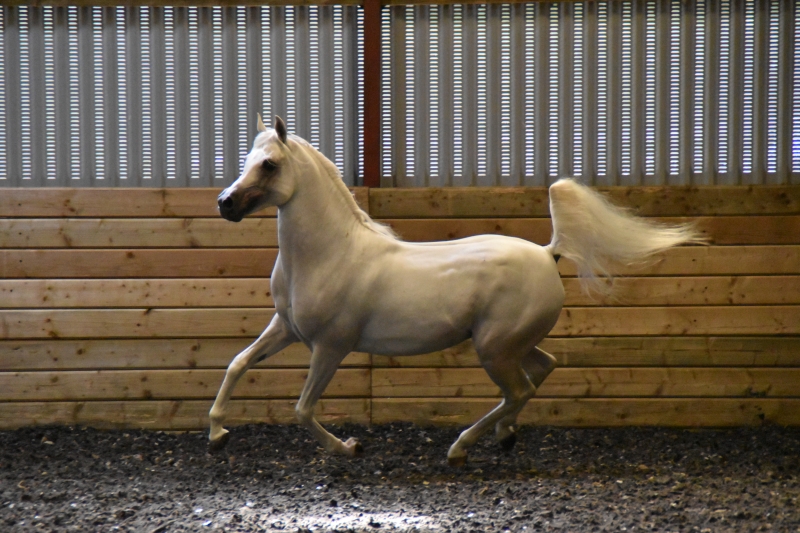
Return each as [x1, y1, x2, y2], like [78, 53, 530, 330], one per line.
[0, 187, 800, 429]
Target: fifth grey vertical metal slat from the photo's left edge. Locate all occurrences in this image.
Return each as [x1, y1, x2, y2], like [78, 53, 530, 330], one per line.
[103, 7, 120, 187]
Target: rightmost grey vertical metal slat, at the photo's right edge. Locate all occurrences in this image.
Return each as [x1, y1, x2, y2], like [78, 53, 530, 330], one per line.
[775, 2, 796, 183]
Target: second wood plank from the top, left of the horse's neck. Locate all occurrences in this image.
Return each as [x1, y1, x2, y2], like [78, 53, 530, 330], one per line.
[0, 217, 278, 249]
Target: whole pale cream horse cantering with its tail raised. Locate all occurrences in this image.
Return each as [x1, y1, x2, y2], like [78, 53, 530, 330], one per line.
[209, 117, 697, 465]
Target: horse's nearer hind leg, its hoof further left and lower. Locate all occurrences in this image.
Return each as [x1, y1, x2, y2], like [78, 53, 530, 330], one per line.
[447, 357, 536, 466]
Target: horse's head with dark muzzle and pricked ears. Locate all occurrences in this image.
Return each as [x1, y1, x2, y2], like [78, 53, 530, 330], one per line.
[217, 115, 294, 222]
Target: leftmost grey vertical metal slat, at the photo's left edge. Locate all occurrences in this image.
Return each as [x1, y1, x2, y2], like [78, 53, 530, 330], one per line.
[0, 6, 22, 187]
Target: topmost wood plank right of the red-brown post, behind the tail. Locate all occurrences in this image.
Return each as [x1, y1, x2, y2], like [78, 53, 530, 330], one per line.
[369, 185, 800, 218]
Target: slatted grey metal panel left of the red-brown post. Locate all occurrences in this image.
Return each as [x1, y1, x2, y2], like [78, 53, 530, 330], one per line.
[0, 6, 363, 187]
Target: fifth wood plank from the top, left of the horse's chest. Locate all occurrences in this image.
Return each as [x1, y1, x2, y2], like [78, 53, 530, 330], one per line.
[0, 309, 275, 339]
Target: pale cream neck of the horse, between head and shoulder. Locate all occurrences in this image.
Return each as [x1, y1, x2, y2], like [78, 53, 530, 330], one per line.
[278, 154, 366, 269]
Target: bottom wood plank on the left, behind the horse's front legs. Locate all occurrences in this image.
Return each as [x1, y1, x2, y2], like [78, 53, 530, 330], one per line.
[0, 398, 370, 431]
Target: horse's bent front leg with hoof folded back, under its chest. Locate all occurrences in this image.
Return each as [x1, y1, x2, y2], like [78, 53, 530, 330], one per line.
[295, 346, 363, 457]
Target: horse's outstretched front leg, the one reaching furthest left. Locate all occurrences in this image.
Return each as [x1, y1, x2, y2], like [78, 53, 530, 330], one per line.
[208, 314, 298, 450]
